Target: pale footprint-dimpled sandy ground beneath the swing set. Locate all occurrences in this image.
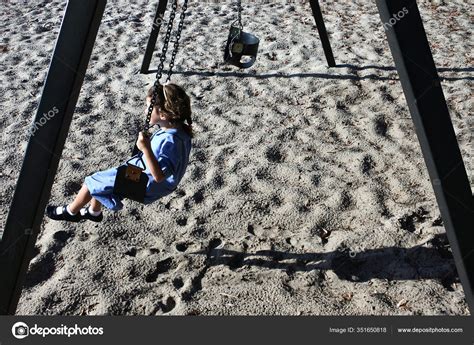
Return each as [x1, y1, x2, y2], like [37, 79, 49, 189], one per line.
[0, 0, 473, 315]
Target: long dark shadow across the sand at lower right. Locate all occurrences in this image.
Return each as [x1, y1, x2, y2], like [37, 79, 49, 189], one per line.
[187, 234, 459, 289]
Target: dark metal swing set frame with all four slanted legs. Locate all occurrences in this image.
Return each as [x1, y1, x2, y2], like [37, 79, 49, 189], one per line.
[0, 0, 474, 315]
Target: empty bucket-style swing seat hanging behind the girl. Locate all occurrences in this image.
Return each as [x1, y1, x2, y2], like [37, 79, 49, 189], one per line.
[224, 26, 260, 68]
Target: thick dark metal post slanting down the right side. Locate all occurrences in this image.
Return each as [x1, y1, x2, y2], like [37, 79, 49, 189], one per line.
[377, 0, 474, 314]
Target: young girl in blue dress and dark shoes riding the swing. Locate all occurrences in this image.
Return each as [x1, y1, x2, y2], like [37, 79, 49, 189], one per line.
[46, 84, 193, 222]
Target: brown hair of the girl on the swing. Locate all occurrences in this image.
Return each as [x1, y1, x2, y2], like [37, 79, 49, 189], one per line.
[147, 84, 193, 137]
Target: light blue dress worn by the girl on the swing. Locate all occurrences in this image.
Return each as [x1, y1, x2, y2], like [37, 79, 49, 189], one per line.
[84, 128, 191, 211]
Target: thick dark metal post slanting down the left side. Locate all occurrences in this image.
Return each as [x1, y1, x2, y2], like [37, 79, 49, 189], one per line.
[0, 0, 107, 315]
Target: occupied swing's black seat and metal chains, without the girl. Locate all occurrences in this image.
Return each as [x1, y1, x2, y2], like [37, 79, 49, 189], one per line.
[113, 0, 188, 203]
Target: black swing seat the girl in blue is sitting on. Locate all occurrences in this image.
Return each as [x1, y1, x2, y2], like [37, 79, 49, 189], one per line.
[113, 157, 148, 203]
